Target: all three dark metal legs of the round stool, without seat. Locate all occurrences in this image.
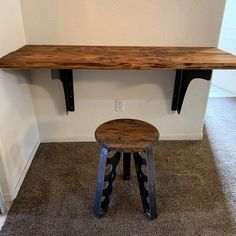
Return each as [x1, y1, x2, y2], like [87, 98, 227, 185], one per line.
[93, 147, 157, 220]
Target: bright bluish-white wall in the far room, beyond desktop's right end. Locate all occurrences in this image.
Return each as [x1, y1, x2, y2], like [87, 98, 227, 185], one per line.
[212, 0, 236, 95]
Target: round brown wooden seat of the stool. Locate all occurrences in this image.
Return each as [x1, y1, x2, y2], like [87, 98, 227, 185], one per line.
[95, 119, 159, 152]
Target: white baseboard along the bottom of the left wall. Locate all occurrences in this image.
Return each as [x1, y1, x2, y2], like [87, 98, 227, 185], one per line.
[3, 139, 40, 201]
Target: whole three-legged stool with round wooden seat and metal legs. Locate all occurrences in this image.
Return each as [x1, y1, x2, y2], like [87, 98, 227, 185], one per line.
[94, 119, 159, 219]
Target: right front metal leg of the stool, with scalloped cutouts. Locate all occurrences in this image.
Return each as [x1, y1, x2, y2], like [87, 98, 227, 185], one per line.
[134, 148, 157, 220]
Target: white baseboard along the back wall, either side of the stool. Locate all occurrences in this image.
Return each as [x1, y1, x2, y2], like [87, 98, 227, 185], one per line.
[41, 133, 203, 143]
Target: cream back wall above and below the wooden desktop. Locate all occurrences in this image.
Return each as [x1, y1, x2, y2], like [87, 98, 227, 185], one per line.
[18, 0, 225, 142]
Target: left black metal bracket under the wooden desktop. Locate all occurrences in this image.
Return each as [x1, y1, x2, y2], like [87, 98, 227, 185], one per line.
[51, 69, 75, 114]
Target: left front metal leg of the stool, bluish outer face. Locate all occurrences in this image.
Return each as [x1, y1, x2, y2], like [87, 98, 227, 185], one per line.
[93, 147, 120, 218]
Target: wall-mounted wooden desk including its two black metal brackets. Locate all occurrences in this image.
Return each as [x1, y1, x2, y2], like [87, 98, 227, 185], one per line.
[0, 45, 236, 113]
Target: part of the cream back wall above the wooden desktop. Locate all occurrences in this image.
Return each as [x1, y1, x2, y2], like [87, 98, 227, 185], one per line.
[21, 0, 225, 46]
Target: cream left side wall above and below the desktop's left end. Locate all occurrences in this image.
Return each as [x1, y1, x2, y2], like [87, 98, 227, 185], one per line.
[0, 0, 39, 200]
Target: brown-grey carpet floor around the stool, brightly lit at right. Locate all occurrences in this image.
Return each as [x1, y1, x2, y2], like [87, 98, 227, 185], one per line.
[0, 98, 236, 236]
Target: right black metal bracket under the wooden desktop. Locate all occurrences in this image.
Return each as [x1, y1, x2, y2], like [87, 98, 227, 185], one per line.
[171, 70, 212, 114]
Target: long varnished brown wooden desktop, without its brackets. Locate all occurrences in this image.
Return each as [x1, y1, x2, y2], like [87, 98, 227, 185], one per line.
[0, 45, 236, 69]
